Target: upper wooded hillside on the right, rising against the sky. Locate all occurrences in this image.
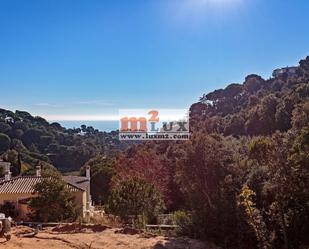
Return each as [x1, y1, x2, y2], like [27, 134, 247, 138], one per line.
[190, 57, 309, 136]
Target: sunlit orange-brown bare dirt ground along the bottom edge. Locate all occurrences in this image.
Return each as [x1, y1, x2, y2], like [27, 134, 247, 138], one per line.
[0, 226, 215, 249]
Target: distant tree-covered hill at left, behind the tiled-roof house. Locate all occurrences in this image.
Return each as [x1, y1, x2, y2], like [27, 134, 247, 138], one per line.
[0, 109, 126, 175]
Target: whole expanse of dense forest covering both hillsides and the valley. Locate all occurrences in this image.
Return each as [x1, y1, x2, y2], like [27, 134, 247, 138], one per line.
[0, 57, 309, 249]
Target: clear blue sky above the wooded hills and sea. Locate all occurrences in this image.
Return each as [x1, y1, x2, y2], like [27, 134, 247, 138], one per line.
[0, 0, 309, 120]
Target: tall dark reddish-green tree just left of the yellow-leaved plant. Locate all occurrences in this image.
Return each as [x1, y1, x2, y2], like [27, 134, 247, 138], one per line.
[176, 133, 252, 248]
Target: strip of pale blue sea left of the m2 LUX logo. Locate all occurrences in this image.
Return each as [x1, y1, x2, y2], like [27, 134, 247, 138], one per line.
[55, 120, 119, 132]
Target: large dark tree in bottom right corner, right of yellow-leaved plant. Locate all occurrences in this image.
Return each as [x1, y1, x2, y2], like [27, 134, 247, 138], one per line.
[247, 131, 309, 249]
